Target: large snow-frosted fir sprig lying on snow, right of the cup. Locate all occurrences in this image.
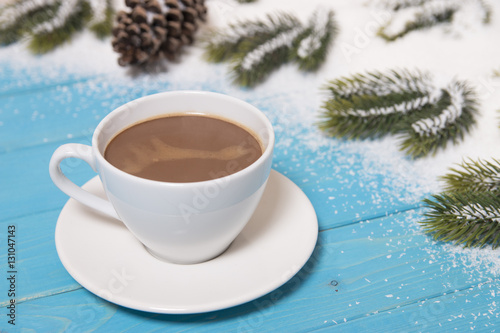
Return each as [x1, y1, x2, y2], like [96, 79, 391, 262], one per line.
[318, 70, 477, 157]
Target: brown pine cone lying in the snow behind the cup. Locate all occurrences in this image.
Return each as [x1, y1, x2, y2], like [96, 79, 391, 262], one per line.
[112, 0, 207, 66]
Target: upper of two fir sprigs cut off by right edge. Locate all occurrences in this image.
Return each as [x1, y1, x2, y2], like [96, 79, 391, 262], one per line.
[441, 159, 500, 192]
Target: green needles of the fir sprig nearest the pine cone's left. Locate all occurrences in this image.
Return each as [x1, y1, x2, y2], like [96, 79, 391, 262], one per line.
[28, 2, 92, 54]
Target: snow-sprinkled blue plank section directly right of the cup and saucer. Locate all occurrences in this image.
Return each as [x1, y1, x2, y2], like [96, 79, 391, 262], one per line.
[273, 147, 425, 229]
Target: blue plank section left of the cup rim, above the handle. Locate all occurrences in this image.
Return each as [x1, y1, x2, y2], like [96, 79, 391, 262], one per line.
[0, 79, 147, 153]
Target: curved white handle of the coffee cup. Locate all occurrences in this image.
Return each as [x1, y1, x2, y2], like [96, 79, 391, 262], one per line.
[49, 143, 119, 220]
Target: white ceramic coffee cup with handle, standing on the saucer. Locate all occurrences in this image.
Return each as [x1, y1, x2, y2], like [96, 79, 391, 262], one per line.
[49, 91, 274, 264]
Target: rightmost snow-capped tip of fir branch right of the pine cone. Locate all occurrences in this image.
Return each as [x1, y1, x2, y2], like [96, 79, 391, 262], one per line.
[292, 10, 338, 71]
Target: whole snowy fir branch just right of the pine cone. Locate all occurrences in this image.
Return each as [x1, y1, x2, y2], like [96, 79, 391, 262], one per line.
[205, 11, 336, 87]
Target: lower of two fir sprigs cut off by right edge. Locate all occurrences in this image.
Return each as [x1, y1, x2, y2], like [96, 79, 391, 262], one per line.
[420, 192, 500, 248]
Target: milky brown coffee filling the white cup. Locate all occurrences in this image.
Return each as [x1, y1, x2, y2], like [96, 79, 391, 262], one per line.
[104, 113, 262, 183]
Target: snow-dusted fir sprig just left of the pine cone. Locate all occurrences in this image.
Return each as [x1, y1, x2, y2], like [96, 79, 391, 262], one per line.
[29, 2, 92, 53]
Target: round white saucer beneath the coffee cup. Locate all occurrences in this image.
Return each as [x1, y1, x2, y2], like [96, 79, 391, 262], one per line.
[55, 170, 318, 314]
